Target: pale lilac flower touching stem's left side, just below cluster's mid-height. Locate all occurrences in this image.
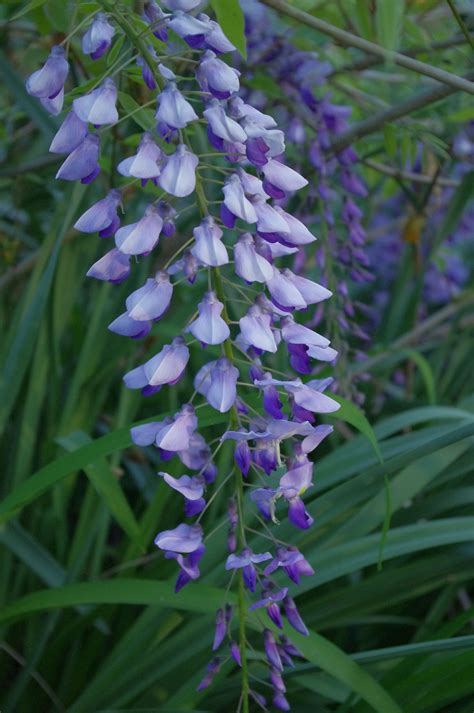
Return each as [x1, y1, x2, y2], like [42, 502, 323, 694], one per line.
[194, 357, 239, 413]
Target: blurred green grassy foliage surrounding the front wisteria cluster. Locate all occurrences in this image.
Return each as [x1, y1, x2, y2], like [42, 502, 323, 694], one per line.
[0, 0, 474, 713]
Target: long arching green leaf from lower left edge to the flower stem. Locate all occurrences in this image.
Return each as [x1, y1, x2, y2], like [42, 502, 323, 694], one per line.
[0, 577, 232, 622]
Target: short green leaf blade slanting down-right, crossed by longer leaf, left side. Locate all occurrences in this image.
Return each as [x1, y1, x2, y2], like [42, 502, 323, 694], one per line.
[58, 432, 140, 541]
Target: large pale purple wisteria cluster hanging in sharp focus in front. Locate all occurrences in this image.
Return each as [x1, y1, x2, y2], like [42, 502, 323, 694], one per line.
[27, 0, 340, 710]
